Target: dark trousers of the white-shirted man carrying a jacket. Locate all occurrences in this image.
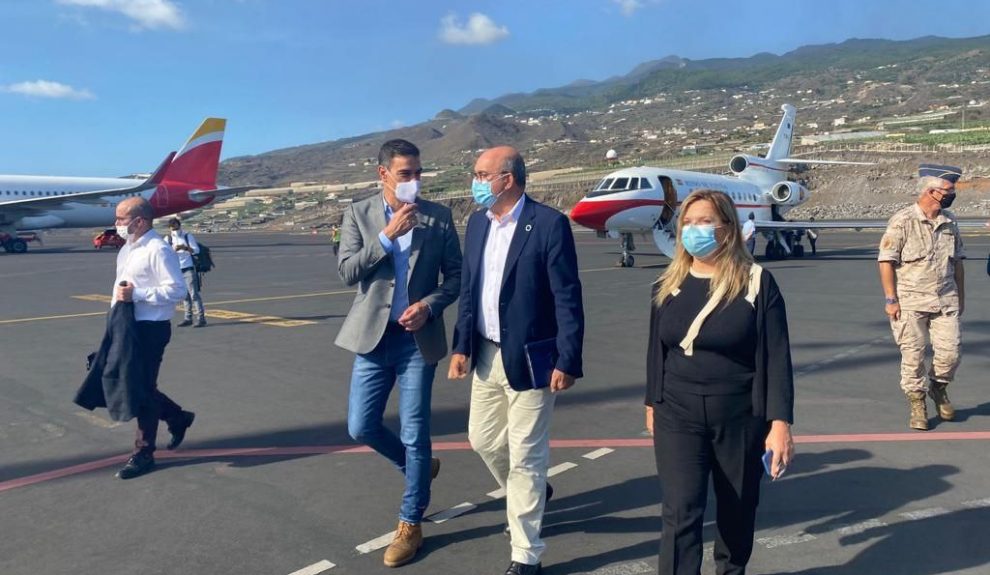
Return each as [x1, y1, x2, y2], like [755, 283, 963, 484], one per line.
[134, 321, 182, 454]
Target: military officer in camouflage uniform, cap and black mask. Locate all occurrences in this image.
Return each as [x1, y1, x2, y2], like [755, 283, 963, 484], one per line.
[877, 164, 965, 430]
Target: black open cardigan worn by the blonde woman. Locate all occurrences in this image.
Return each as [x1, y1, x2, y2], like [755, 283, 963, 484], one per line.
[646, 270, 794, 423]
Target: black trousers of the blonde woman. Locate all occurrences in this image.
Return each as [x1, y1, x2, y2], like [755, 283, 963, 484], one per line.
[653, 390, 770, 575]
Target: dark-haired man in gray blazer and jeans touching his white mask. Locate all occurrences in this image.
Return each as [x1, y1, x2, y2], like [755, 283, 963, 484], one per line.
[336, 140, 461, 567]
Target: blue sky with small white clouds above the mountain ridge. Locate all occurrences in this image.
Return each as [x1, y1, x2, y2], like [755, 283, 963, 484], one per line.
[0, 0, 990, 176]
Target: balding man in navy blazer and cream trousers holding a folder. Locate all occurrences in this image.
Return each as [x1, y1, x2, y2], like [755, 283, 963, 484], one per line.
[448, 146, 584, 575]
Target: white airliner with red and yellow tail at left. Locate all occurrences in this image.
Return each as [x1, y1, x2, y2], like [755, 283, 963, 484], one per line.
[0, 118, 250, 253]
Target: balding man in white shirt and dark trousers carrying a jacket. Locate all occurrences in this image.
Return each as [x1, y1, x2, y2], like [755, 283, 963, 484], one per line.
[110, 197, 195, 479]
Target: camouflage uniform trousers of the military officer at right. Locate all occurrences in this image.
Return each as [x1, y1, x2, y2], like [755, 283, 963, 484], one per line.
[890, 309, 960, 393]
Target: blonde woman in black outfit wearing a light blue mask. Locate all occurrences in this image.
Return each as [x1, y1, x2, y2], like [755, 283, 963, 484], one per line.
[646, 190, 794, 575]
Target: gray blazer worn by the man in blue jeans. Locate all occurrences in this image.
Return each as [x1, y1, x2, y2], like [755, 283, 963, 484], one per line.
[336, 194, 461, 363]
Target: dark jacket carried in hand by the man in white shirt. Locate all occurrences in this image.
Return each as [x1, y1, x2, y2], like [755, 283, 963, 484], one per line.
[75, 301, 146, 421]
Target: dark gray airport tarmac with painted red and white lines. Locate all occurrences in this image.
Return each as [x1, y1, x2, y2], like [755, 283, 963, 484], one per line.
[0, 227, 990, 575]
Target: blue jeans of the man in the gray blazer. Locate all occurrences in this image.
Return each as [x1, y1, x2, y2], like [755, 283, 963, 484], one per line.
[347, 324, 437, 524]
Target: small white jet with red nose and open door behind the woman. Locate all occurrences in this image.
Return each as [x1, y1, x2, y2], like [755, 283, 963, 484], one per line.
[571, 104, 956, 267]
